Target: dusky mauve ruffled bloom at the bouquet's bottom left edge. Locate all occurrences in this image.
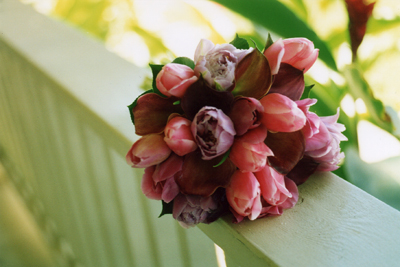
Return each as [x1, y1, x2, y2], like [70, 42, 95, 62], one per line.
[172, 194, 218, 228]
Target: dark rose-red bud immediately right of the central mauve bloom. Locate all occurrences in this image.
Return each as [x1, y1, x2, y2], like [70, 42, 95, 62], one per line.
[229, 97, 264, 136]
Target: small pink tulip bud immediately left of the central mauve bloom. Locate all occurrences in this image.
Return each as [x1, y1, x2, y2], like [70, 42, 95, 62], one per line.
[164, 116, 197, 156]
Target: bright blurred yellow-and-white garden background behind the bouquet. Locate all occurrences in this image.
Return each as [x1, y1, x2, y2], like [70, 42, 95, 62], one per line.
[23, 0, 400, 209]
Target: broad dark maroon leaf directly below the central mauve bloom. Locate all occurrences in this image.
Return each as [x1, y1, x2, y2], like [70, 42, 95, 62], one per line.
[175, 150, 236, 196]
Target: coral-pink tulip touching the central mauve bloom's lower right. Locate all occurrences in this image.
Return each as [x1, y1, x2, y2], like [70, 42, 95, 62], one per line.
[229, 126, 274, 172]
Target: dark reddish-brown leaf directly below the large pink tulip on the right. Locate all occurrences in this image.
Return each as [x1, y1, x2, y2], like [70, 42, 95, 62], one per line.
[264, 130, 305, 175]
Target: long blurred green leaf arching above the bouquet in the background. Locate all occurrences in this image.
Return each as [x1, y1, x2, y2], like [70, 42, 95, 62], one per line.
[213, 0, 337, 70]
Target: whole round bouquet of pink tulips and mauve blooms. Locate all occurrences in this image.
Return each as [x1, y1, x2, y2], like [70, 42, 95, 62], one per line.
[126, 37, 346, 227]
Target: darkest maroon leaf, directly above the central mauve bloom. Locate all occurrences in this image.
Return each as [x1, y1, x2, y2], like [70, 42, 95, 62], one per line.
[181, 77, 233, 120]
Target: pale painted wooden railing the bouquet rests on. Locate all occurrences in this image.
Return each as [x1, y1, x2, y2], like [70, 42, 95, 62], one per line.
[0, 0, 400, 267]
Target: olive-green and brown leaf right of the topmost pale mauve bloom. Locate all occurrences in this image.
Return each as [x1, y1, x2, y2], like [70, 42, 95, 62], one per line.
[232, 49, 272, 99]
